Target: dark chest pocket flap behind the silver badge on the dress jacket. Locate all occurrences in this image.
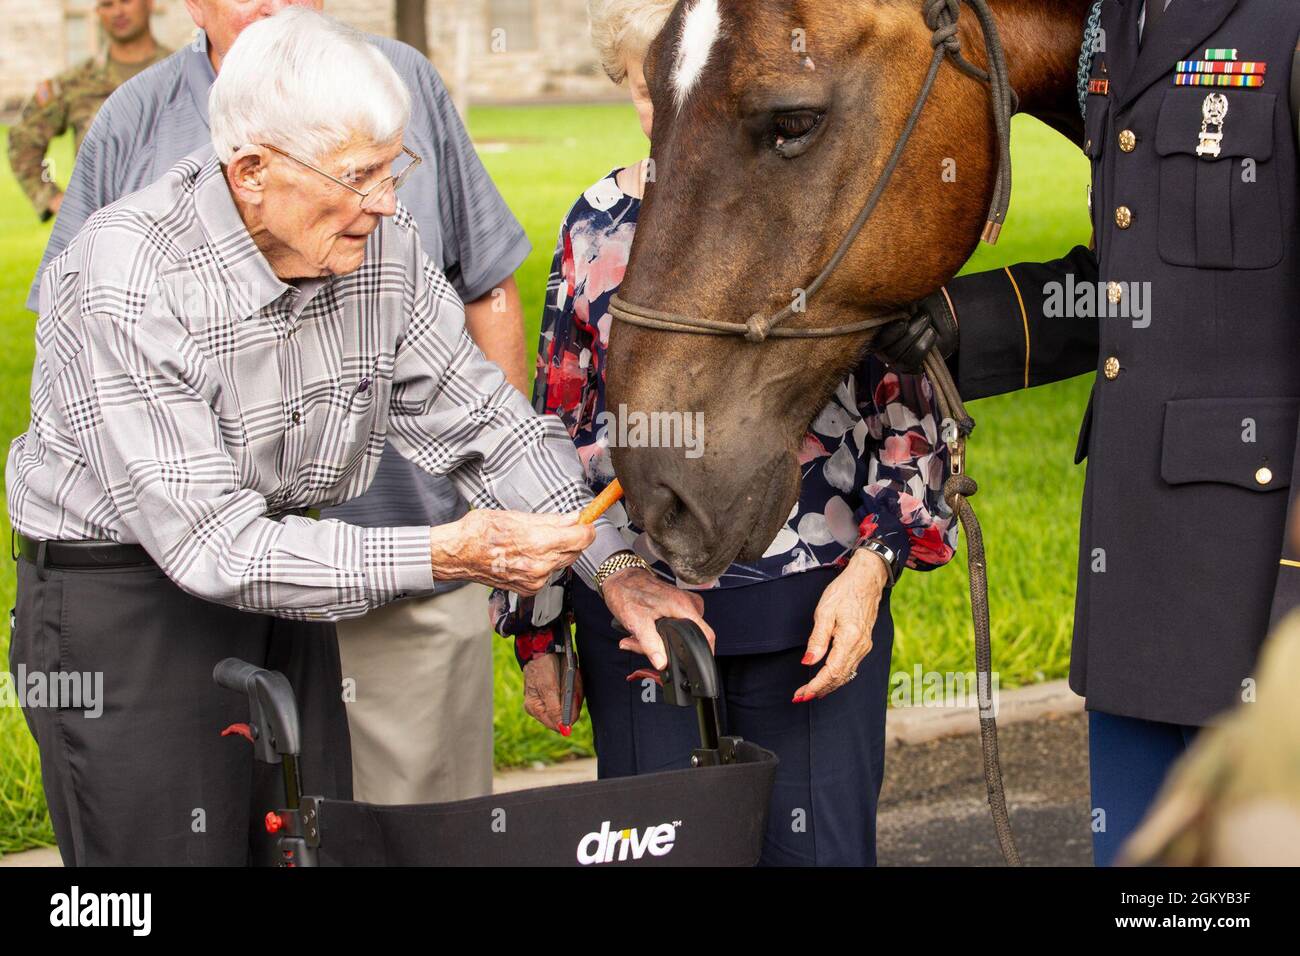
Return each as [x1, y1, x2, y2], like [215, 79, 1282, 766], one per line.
[1156, 86, 1277, 163]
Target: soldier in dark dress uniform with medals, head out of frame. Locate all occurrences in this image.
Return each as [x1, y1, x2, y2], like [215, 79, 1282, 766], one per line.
[878, 0, 1300, 865]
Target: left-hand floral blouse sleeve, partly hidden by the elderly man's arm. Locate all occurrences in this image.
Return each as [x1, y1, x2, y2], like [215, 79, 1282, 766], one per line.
[489, 222, 580, 667]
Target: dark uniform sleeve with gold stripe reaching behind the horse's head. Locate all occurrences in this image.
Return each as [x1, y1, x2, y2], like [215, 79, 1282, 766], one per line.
[944, 246, 1105, 402]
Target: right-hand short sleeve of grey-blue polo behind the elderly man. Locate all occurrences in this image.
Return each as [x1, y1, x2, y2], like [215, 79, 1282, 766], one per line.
[413, 49, 532, 302]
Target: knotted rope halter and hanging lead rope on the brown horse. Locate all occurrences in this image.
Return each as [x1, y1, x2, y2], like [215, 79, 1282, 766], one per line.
[610, 0, 1021, 866]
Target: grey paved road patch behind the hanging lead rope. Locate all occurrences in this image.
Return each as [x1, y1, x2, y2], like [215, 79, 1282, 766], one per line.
[876, 713, 1092, 866]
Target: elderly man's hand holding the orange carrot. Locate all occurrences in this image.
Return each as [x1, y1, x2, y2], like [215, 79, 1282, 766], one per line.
[429, 507, 595, 596]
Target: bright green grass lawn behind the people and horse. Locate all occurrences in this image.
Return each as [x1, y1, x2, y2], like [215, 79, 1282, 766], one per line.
[0, 105, 1088, 853]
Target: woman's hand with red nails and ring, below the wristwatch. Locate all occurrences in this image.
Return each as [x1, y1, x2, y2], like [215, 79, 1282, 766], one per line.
[794, 550, 889, 704]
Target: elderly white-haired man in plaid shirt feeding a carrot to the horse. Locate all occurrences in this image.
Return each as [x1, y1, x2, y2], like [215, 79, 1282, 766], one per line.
[5, 8, 699, 864]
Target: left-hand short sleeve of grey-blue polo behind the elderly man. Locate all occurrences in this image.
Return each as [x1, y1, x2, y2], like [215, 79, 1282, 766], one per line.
[27, 88, 126, 312]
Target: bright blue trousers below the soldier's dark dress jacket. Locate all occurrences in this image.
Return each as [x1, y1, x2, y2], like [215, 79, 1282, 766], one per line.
[1088, 710, 1200, 866]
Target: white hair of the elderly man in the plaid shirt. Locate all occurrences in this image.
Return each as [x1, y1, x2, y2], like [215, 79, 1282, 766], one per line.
[208, 5, 411, 163]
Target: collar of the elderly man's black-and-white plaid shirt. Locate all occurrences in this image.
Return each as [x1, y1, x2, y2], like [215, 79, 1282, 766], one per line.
[194, 152, 299, 319]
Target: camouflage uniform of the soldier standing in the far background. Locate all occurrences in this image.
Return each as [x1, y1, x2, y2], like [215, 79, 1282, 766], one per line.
[9, 46, 172, 221]
